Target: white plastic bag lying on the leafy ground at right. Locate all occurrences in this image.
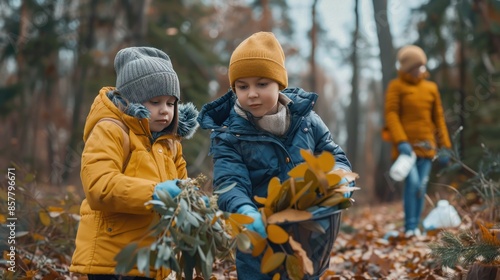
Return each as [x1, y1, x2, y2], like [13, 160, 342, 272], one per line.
[423, 199, 462, 230]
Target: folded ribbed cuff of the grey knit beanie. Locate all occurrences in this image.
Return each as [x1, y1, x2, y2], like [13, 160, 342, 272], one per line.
[117, 72, 180, 103]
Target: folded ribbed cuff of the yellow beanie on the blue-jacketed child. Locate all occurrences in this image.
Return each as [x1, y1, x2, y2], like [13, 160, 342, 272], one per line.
[229, 57, 288, 90]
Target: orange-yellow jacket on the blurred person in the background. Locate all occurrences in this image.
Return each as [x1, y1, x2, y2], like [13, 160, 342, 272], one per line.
[385, 72, 451, 159]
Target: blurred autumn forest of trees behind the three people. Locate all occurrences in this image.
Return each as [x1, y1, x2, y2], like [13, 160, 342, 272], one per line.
[0, 0, 500, 205]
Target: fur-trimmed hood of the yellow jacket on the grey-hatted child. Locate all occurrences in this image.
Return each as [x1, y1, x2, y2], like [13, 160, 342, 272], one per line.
[83, 87, 199, 140]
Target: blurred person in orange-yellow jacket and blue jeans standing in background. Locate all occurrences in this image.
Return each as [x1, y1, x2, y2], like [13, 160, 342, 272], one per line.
[385, 45, 451, 236]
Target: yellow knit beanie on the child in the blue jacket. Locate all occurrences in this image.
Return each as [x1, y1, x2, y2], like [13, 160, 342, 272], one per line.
[228, 32, 288, 90]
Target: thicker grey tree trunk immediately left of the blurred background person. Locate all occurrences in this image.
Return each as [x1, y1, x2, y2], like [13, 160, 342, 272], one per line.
[373, 0, 396, 201]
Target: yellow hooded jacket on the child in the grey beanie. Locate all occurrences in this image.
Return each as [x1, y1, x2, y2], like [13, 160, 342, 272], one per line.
[70, 87, 187, 279]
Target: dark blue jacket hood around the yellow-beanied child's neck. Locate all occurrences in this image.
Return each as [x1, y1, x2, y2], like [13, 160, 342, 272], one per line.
[198, 88, 318, 129]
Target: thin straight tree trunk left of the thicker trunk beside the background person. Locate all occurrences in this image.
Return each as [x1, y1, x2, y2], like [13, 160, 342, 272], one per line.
[347, 0, 360, 168]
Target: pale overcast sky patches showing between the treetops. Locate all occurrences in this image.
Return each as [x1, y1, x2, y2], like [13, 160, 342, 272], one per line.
[288, 0, 426, 95]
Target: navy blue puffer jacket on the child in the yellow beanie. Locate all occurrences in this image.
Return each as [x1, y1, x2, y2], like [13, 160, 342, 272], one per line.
[198, 88, 351, 213]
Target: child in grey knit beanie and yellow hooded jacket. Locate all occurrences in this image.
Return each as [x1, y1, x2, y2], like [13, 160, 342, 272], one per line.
[70, 47, 198, 280]
